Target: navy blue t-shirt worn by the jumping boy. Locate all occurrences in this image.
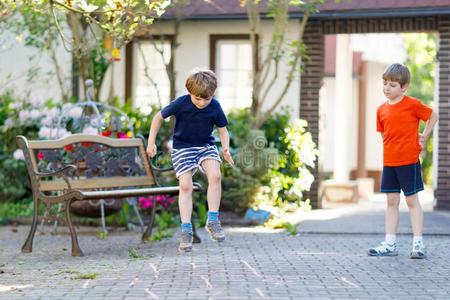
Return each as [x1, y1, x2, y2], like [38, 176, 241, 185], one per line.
[161, 94, 228, 149]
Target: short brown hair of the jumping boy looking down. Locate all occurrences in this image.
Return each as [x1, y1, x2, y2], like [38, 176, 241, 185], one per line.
[185, 69, 217, 99]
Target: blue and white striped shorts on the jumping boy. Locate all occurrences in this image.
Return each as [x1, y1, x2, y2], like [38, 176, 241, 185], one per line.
[172, 145, 222, 178]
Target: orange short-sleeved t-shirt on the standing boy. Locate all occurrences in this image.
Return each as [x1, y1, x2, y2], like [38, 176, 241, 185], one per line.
[377, 96, 433, 167]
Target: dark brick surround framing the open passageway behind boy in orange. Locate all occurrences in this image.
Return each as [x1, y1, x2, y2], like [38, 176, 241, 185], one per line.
[300, 16, 450, 210]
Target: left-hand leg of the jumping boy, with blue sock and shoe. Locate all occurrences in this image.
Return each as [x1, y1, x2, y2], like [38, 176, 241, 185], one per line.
[178, 171, 194, 252]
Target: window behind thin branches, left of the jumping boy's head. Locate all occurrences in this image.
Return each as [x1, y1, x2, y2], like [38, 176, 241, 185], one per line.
[132, 38, 171, 113]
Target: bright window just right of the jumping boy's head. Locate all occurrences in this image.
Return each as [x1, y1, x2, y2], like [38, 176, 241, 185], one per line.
[211, 35, 254, 111]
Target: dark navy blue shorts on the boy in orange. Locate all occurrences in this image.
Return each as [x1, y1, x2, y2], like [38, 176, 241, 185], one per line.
[381, 161, 423, 196]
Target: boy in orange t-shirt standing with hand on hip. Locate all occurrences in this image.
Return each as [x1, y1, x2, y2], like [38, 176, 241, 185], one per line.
[368, 64, 438, 258]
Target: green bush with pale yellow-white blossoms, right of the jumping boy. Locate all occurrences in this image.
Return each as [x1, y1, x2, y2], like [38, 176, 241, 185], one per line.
[222, 109, 318, 213]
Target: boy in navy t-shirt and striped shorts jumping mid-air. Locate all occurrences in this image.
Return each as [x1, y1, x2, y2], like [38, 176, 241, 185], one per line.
[147, 70, 234, 252]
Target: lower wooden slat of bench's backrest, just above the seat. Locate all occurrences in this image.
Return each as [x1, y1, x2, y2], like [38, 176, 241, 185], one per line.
[40, 176, 153, 192]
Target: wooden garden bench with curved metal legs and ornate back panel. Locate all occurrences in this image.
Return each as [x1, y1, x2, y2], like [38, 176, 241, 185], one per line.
[16, 134, 202, 256]
